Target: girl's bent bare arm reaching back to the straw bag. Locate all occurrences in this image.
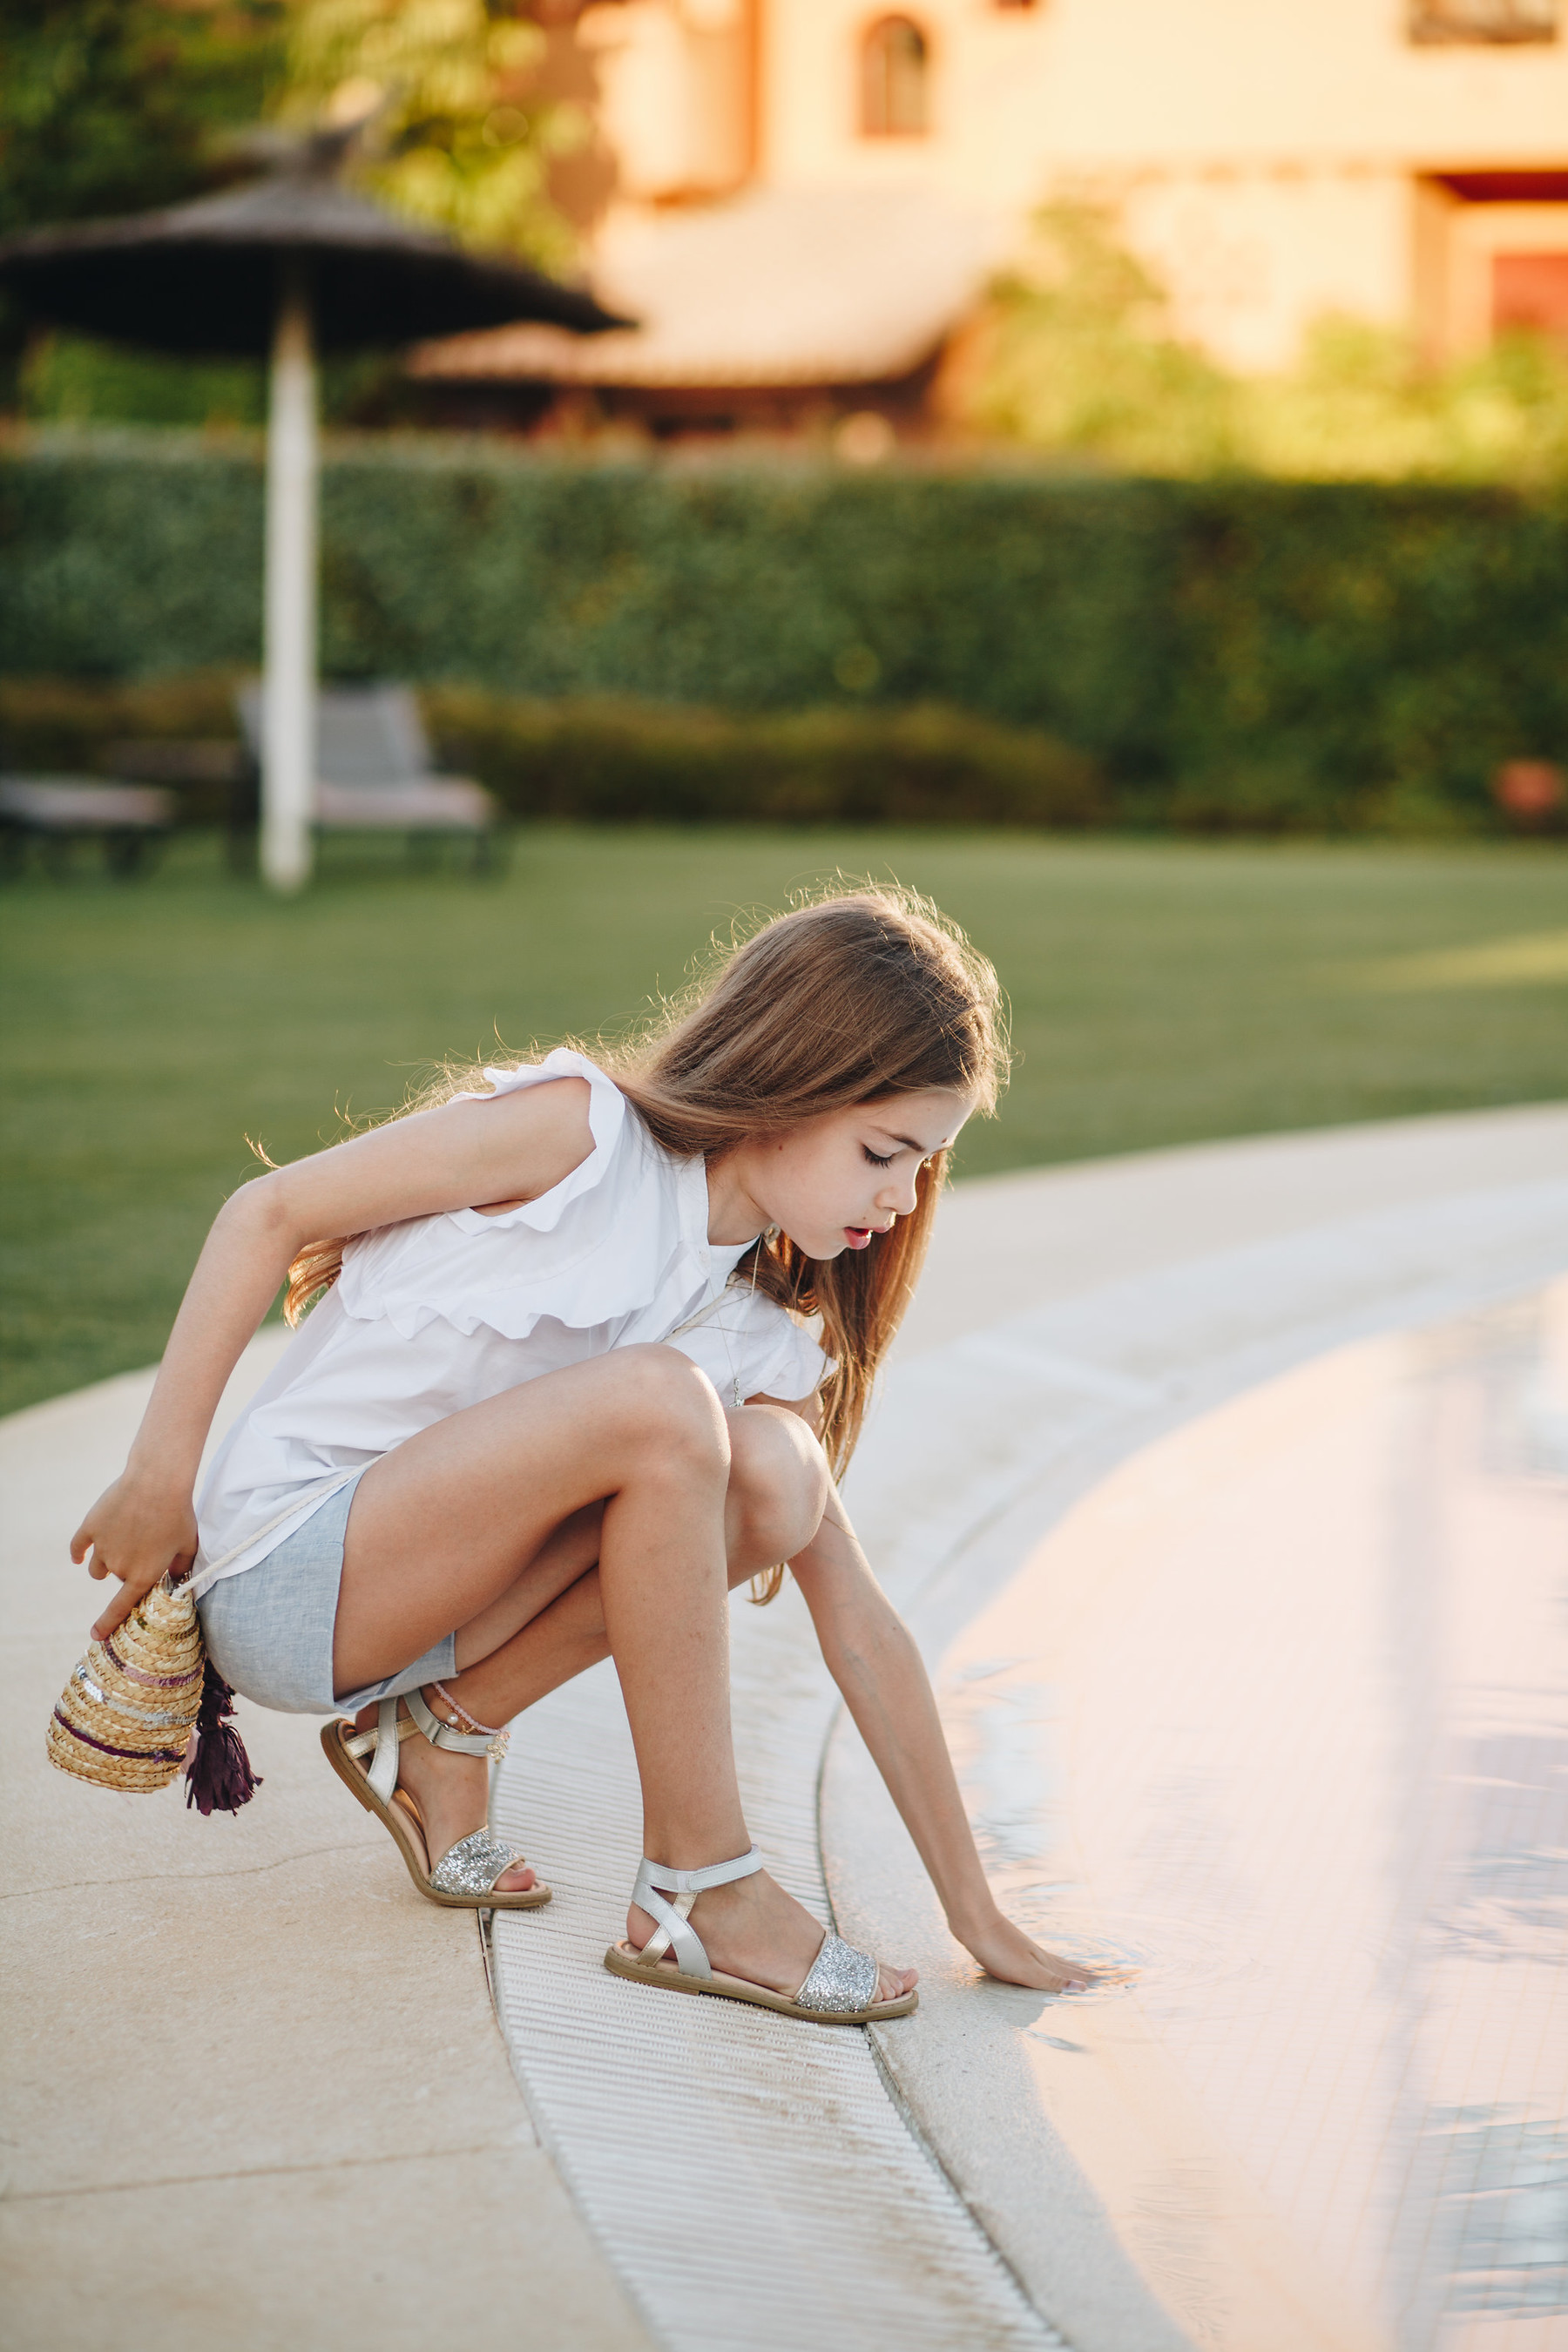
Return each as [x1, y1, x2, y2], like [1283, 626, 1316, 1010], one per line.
[71, 1078, 592, 1637]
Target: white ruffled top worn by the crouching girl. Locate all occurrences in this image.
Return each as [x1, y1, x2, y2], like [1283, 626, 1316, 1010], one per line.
[193, 1047, 832, 1595]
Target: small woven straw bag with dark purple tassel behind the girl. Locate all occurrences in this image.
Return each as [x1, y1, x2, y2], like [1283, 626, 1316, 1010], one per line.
[50, 1576, 259, 1814]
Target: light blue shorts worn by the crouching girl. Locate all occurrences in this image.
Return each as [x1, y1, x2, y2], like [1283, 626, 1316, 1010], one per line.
[195, 1477, 458, 1714]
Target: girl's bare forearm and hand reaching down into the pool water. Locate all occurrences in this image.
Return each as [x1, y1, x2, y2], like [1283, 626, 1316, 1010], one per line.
[790, 1491, 1093, 1992]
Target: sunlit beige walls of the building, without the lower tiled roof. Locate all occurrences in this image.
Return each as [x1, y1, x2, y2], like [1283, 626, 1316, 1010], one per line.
[592, 0, 1568, 367]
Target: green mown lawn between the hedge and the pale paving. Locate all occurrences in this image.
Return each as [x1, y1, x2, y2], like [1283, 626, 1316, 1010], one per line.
[0, 830, 1568, 1409]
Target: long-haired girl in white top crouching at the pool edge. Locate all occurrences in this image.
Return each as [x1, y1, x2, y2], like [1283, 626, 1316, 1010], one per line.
[71, 891, 1088, 2025]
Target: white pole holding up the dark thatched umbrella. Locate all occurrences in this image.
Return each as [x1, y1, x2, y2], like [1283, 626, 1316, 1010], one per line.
[261, 261, 317, 891]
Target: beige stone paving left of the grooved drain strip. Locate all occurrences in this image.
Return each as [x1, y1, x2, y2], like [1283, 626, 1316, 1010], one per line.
[0, 1336, 646, 2352]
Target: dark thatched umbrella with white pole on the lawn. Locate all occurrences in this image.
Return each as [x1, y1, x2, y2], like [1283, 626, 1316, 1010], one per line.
[0, 132, 628, 889]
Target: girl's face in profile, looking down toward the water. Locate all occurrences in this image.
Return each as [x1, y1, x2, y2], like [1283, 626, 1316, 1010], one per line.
[707, 1086, 973, 1259]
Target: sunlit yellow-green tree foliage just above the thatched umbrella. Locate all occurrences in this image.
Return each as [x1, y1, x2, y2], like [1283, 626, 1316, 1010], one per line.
[282, 0, 590, 268]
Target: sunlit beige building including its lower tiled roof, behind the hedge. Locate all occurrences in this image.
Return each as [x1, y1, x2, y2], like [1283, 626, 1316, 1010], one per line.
[413, 0, 1568, 432]
